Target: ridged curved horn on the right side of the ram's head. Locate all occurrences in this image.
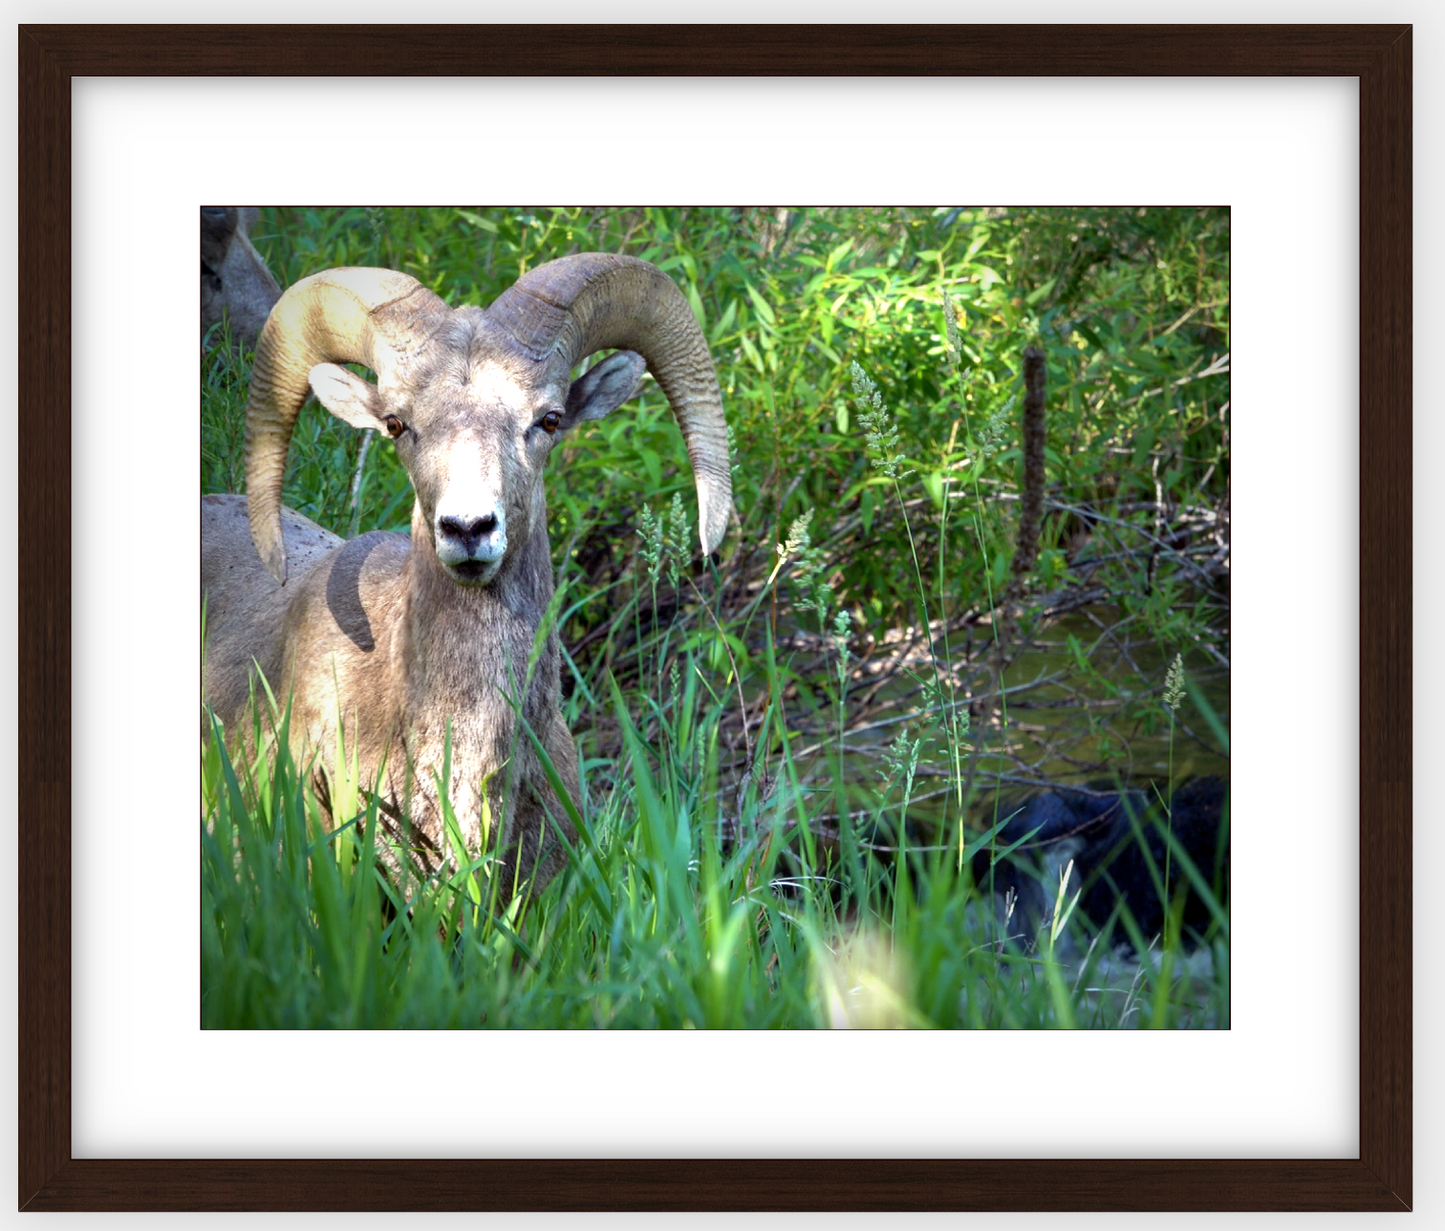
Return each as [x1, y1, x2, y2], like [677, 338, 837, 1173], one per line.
[487, 253, 733, 555]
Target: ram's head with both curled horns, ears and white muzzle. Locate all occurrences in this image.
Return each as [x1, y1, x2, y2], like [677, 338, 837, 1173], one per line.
[247, 253, 733, 585]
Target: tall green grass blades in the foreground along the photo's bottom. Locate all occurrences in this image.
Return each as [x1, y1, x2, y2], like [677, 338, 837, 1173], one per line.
[202, 644, 1228, 1029]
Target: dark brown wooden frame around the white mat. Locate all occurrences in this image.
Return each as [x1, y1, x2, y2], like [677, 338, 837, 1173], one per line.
[19, 26, 1412, 1211]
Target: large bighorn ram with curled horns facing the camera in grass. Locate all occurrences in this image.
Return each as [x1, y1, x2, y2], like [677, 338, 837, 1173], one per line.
[201, 253, 733, 897]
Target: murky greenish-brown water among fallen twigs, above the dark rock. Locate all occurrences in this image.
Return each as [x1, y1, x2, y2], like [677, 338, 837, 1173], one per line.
[789, 607, 1230, 829]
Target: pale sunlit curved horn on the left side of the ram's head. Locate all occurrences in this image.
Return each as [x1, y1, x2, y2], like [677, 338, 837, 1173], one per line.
[246, 269, 451, 584]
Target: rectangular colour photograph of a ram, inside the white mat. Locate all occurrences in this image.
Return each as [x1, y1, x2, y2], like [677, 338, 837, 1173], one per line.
[199, 204, 1231, 1030]
